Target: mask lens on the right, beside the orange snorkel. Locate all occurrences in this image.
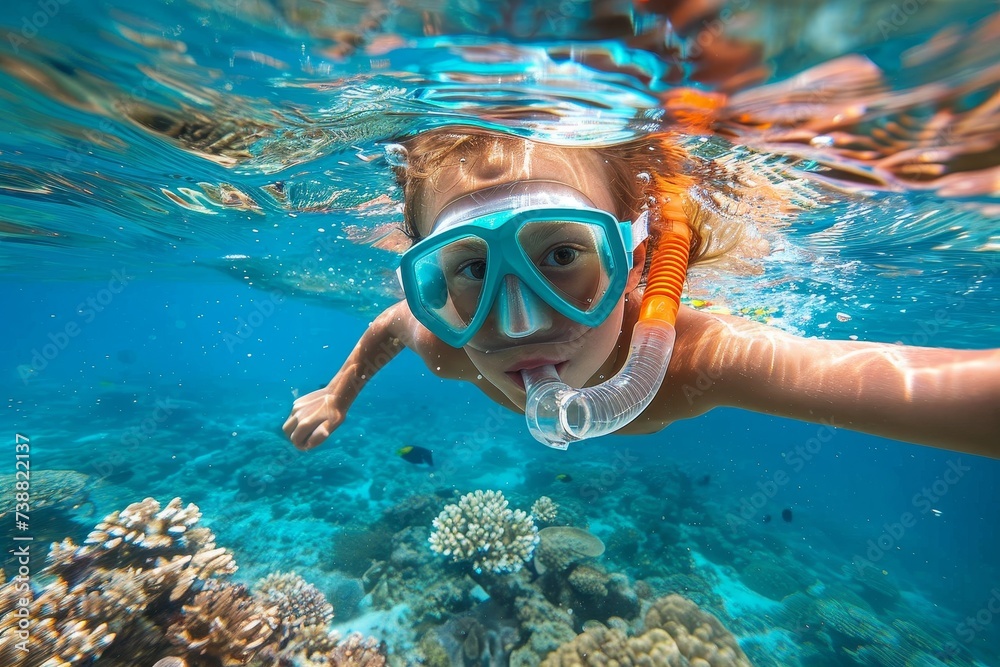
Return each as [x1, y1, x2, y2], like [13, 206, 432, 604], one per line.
[518, 220, 612, 313]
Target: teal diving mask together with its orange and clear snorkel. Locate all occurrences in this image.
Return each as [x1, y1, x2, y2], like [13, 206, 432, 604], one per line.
[398, 181, 690, 449]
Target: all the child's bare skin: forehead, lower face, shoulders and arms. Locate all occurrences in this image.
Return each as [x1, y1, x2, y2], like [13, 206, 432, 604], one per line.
[284, 136, 1000, 458]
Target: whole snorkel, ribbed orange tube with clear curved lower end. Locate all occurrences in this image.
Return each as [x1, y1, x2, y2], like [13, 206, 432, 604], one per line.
[522, 166, 691, 449]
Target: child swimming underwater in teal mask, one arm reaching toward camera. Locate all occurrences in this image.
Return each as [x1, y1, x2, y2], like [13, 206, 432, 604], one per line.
[284, 127, 1000, 457]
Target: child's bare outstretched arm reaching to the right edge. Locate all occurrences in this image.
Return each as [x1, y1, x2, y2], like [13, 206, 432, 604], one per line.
[671, 308, 1000, 458]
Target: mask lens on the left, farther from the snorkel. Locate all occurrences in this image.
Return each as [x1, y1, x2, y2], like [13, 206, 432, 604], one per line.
[414, 236, 488, 333]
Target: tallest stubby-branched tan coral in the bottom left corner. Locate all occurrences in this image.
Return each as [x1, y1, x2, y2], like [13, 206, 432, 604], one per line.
[0, 498, 242, 667]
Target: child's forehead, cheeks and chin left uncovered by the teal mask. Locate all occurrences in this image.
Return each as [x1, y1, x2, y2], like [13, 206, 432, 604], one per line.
[408, 139, 644, 408]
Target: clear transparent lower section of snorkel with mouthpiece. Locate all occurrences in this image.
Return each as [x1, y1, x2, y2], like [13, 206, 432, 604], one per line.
[521, 321, 675, 449]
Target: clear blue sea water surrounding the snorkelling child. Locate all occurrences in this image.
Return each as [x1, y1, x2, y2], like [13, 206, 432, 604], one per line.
[0, 0, 1000, 665]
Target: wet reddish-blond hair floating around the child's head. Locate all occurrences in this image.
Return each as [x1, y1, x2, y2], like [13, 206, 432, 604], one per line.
[393, 127, 728, 278]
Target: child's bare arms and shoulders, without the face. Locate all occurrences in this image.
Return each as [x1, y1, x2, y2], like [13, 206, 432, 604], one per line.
[284, 299, 1000, 458]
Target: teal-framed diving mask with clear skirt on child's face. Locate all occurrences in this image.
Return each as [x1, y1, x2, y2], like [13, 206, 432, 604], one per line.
[398, 181, 646, 347]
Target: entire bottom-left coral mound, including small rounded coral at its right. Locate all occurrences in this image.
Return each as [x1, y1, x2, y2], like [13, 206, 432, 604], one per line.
[0, 498, 385, 667]
